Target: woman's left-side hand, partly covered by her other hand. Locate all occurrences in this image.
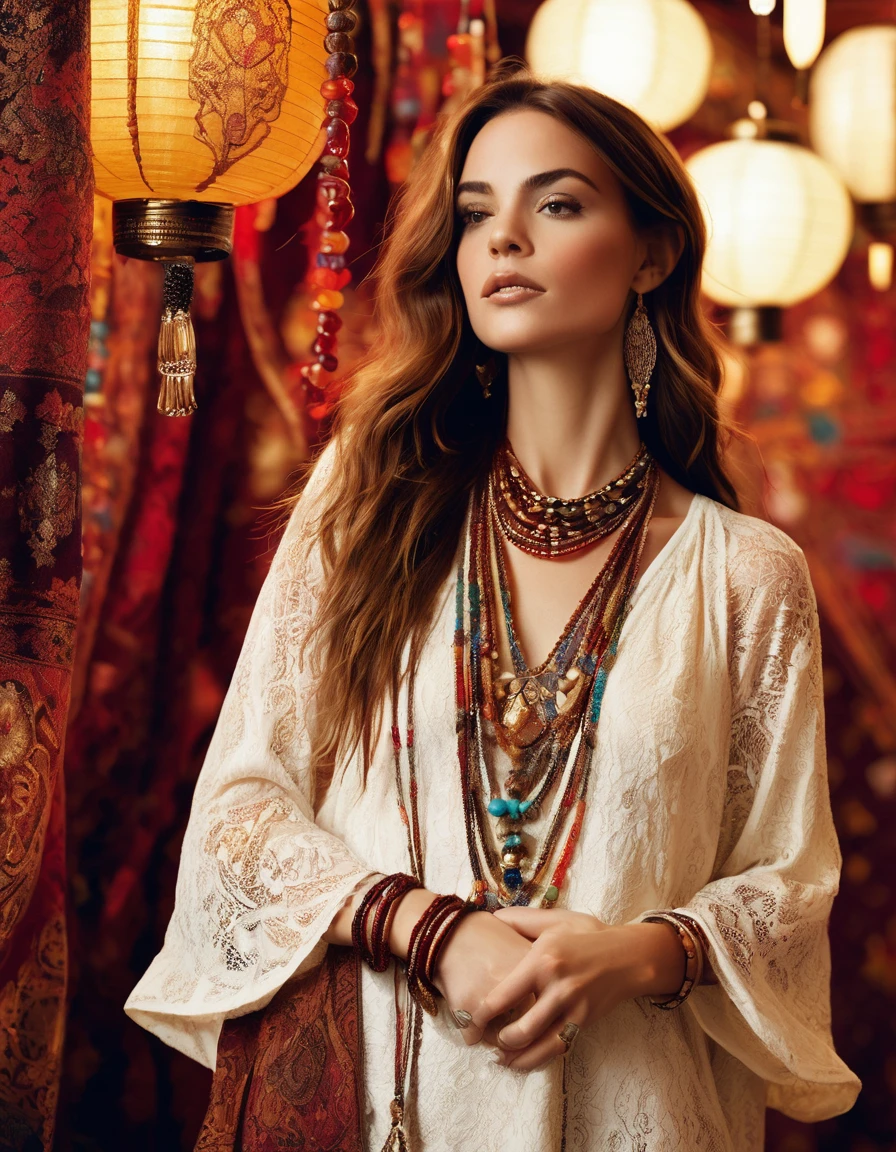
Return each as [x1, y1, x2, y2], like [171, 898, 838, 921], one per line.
[433, 912, 532, 1045]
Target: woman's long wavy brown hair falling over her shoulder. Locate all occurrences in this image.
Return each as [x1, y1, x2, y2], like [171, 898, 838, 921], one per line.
[297, 70, 738, 797]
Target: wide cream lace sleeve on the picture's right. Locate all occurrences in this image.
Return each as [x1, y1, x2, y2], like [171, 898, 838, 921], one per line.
[654, 521, 860, 1121]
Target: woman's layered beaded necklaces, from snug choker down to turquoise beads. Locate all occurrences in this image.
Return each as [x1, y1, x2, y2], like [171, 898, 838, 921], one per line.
[455, 445, 659, 908]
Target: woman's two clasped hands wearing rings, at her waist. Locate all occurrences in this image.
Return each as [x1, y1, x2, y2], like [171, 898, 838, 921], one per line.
[435, 908, 683, 1071]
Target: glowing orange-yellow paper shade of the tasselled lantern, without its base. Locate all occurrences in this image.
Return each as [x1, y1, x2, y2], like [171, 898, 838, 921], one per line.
[90, 0, 327, 204]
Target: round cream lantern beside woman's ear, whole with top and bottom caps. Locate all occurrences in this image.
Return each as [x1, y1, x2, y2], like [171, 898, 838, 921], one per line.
[686, 119, 853, 343]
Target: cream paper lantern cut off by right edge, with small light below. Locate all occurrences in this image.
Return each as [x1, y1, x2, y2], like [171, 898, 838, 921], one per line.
[808, 24, 896, 289]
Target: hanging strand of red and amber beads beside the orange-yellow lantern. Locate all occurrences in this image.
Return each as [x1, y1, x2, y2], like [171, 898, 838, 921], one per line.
[299, 0, 358, 420]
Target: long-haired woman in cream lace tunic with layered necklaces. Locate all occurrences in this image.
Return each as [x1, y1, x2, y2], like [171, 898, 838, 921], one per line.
[127, 75, 859, 1152]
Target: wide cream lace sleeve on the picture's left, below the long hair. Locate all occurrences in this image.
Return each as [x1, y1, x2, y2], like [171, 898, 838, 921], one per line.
[126, 435, 373, 1068]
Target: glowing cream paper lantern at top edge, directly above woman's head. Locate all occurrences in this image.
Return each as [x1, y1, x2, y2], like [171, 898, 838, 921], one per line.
[526, 0, 713, 131]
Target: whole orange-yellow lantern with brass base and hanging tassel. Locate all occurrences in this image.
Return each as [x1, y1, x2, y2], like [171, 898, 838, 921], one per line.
[91, 0, 329, 416]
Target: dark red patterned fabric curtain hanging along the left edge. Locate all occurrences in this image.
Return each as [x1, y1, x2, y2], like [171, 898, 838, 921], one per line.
[0, 0, 93, 1150]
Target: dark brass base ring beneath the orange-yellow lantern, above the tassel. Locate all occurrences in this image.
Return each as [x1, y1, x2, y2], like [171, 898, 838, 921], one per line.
[112, 199, 234, 264]
